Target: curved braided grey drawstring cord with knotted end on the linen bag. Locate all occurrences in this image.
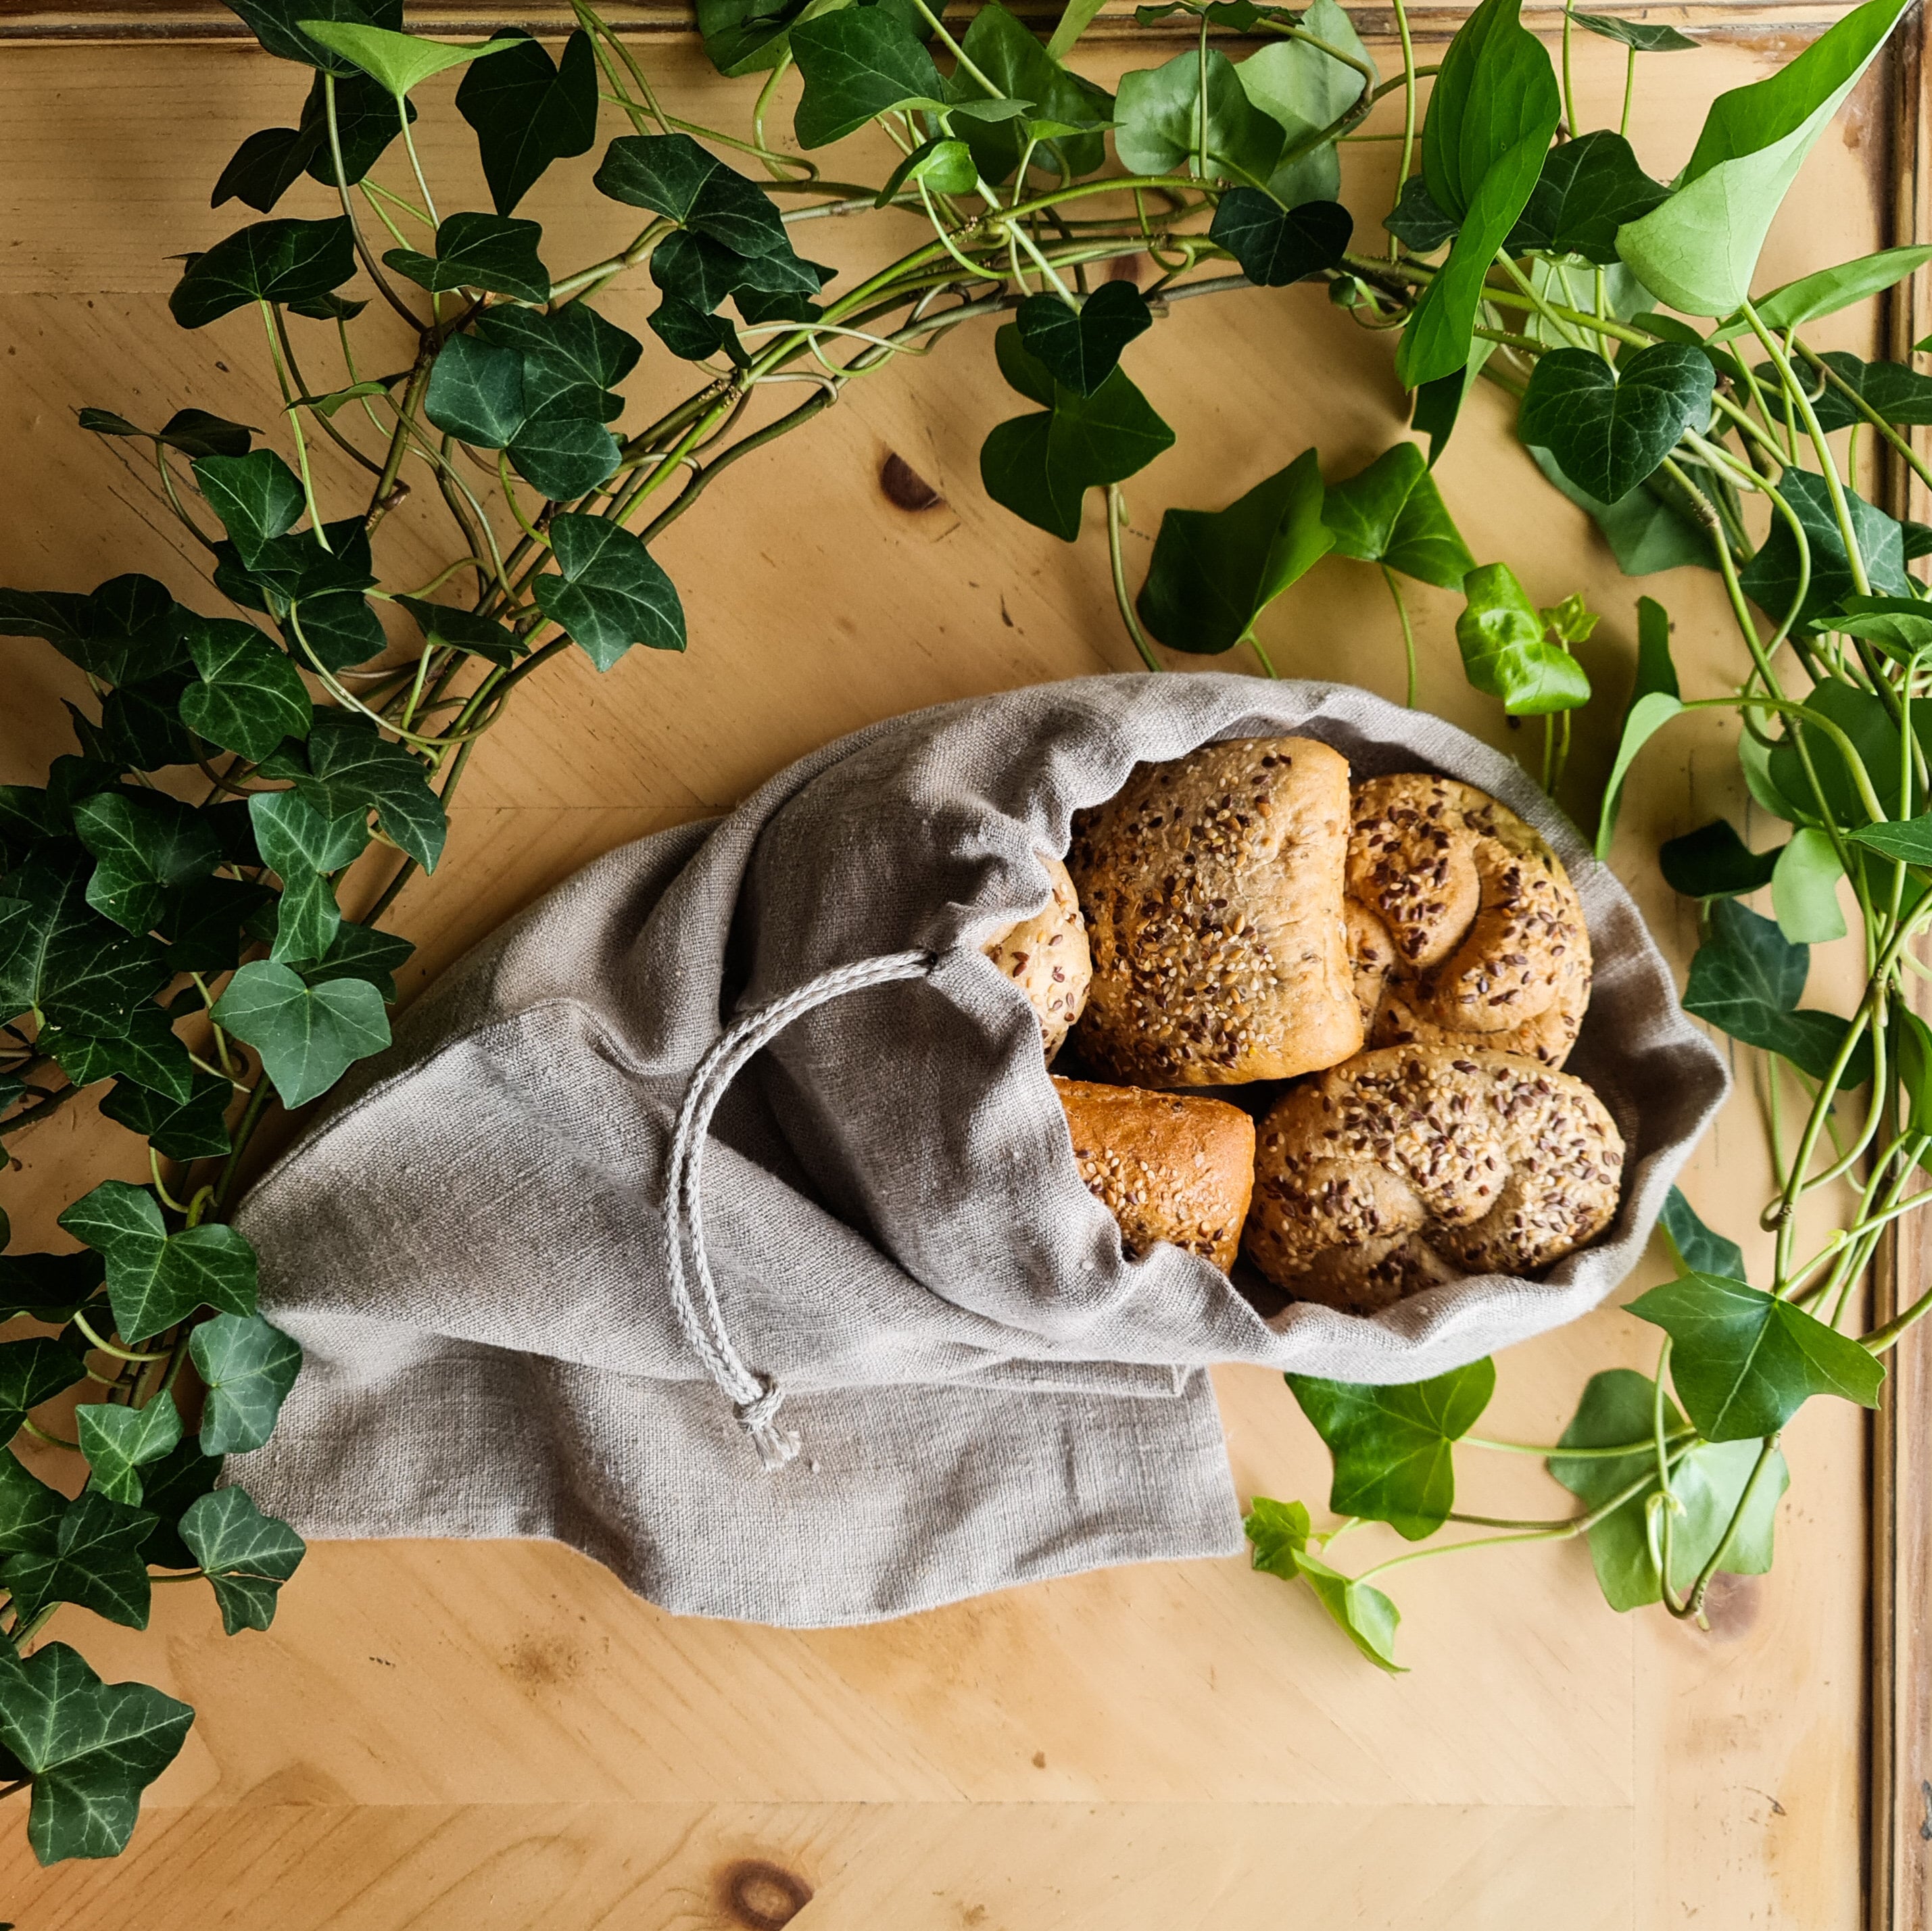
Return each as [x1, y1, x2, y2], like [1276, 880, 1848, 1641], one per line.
[662, 952, 935, 1471]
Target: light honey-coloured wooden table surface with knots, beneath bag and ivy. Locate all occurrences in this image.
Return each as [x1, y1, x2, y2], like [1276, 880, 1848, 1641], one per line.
[0, 18, 1887, 1931]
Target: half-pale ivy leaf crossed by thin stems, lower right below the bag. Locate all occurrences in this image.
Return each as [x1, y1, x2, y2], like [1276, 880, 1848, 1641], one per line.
[1547, 1367, 1791, 1613]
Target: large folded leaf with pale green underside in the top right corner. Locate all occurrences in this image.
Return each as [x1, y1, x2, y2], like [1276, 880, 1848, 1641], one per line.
[1622, 0, 1905, 315]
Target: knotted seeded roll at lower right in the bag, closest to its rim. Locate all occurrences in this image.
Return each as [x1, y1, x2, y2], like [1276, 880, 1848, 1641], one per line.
[1246, 1045, 1623, 1313]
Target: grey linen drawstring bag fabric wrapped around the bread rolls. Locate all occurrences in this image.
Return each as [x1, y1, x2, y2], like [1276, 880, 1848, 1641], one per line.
[232, 674, 1725, 1626]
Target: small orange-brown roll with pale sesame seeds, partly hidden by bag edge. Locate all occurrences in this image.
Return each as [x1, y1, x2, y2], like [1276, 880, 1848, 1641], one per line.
[1053, 1075, 1254, 1275]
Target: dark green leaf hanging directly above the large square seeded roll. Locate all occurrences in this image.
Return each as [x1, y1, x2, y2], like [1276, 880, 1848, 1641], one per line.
[1134, 450, 1335, 655]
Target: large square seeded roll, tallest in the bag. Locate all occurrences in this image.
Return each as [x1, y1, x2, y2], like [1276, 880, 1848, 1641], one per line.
[1067, 737, 1362, 1087]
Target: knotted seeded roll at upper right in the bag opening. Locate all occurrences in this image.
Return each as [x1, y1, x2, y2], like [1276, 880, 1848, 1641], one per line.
[1349, 773, 1590, 1066]
